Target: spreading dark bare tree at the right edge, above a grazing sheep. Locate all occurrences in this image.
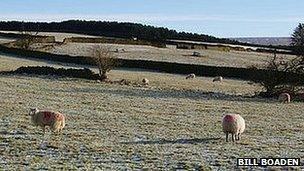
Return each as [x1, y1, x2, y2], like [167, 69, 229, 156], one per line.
[249, 51, 304, 96]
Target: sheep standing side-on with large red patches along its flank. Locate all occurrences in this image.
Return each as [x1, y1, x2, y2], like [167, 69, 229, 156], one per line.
[29, 108, 65, 133]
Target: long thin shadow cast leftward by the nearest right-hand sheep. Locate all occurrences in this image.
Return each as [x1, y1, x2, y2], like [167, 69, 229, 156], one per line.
[121, 138, 221, 145]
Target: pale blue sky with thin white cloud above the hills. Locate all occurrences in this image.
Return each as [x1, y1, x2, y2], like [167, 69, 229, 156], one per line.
[0, 0, 304, 38]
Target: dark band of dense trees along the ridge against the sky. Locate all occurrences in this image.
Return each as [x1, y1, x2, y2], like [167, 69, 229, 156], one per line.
[0, 20, 239, 44]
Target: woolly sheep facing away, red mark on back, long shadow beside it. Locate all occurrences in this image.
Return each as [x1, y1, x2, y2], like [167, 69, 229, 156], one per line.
[222, 114, 245, 142]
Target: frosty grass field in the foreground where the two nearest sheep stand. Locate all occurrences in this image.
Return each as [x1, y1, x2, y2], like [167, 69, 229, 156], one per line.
[0, 55, 304, 170]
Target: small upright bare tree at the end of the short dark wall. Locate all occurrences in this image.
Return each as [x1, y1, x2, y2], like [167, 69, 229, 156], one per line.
[91, 45, 118, 81]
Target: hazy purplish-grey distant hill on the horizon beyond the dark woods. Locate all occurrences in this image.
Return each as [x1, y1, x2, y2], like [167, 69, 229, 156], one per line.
[230, 37, 291, 46]
